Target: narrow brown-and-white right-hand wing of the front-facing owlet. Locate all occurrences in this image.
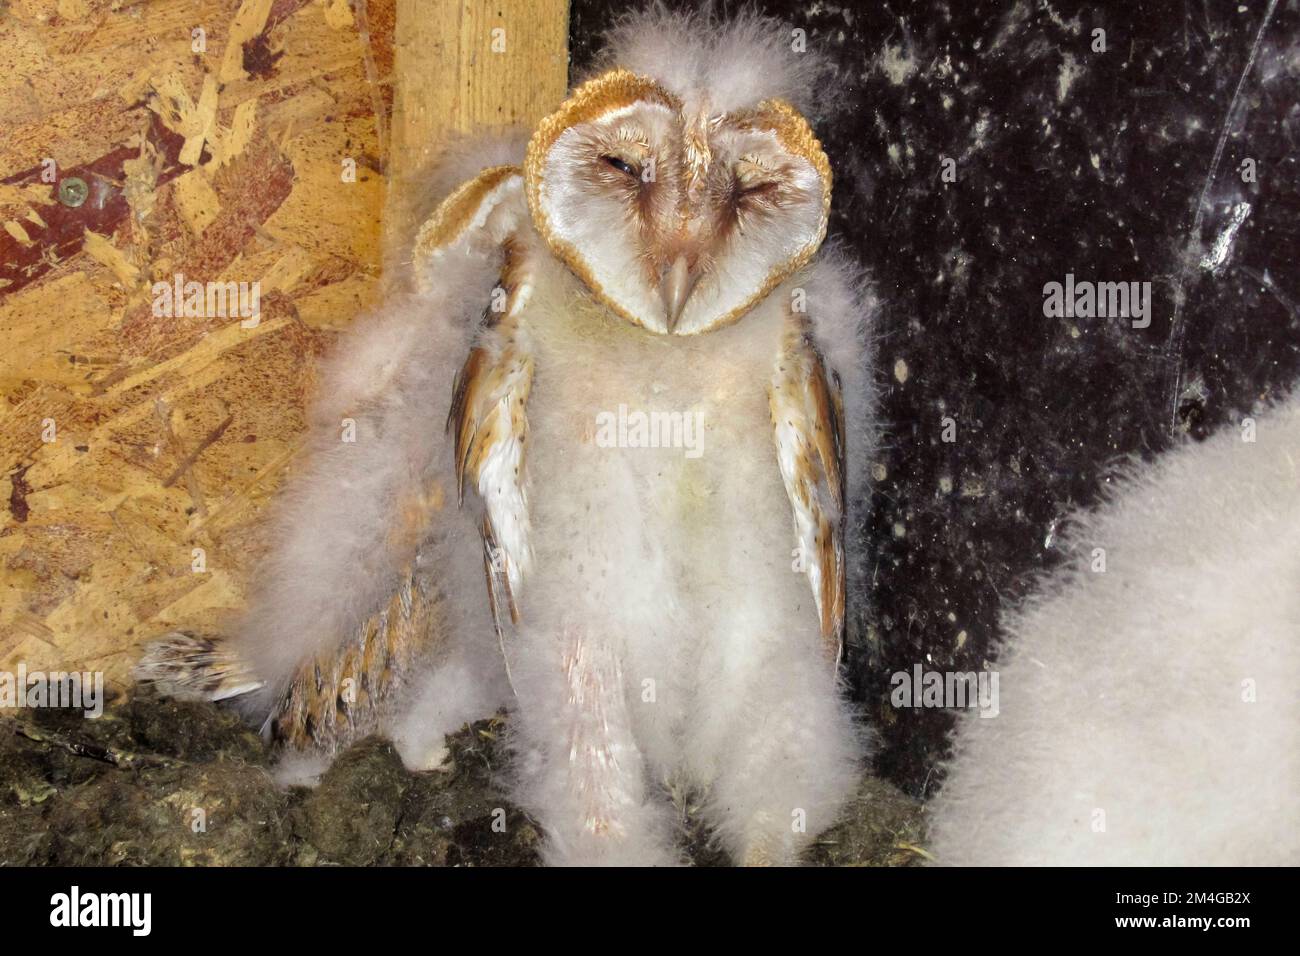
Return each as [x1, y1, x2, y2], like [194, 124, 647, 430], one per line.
[768, 313, 846, 659]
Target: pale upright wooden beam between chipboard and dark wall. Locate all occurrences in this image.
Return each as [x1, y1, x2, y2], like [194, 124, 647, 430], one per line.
[387, 0, 568, 234]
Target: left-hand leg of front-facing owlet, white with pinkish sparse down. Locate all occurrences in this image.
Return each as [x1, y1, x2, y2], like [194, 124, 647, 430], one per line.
[511, 623, 680, 866]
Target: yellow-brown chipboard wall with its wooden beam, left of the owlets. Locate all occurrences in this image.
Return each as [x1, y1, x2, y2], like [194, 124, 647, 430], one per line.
[0, 0, 567, 685]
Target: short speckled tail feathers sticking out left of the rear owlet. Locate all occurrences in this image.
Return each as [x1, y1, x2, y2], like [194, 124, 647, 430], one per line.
[133, 631, 264, 701]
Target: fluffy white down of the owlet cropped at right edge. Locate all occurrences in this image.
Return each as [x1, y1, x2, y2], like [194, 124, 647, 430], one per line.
[931, 398, 1300, 865]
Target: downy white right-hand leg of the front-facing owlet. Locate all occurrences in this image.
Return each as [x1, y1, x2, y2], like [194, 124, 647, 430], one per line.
[688, 622, 861, 866]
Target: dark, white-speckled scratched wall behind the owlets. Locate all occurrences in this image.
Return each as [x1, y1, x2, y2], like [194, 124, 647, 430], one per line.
[571, 0, 1300, 796]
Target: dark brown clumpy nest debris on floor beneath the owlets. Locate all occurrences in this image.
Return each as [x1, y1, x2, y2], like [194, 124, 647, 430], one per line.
[0, 693, 927, 866]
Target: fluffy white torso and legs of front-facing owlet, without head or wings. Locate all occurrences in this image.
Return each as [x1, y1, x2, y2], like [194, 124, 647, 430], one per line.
[496, 243, 870, 862]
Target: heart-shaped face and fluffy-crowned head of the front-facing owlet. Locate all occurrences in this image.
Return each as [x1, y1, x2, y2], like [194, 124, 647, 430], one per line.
[524, 12, 831, 334]
